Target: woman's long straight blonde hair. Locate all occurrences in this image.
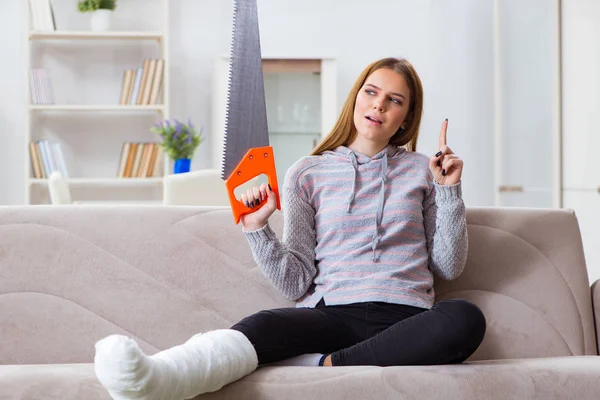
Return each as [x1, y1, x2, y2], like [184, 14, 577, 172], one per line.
[311, 58, 423, 155]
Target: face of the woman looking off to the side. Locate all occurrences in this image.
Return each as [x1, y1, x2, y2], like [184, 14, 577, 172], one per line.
[354, 68, 410, 145]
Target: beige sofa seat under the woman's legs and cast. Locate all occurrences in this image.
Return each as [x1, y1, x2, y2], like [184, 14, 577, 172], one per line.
[0, 356, 600, 400]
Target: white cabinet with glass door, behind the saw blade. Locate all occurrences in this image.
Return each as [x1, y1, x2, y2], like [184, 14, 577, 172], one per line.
[211, 56, 337, 185]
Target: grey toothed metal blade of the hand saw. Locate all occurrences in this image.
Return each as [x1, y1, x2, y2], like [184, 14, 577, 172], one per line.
[221, 0, 269, 179]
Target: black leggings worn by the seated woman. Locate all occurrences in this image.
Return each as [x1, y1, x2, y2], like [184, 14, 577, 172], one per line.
[232, 299, 486, 367]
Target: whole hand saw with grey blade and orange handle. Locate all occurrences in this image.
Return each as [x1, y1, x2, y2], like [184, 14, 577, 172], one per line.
[221, 0, 281, 224]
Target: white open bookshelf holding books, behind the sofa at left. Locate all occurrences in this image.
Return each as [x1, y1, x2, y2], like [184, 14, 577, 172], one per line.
[24, 0, 170, 204]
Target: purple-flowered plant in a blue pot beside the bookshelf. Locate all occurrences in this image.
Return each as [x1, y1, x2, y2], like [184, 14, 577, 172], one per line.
[150, 119, 203, 174]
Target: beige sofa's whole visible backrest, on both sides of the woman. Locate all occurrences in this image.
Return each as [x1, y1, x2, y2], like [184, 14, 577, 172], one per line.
[0, 205, 596, 364]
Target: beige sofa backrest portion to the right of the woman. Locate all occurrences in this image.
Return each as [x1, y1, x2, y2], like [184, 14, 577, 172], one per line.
[435, 208, 598, 360]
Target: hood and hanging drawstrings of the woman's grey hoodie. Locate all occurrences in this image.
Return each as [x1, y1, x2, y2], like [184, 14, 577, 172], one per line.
[323, 144, 406, 261]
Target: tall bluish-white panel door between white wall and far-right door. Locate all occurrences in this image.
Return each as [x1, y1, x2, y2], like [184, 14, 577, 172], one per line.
[495, 0, 560, 207]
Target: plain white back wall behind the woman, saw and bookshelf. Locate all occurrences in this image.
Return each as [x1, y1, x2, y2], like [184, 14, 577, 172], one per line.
[0, 0, 494, 205]
